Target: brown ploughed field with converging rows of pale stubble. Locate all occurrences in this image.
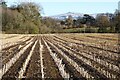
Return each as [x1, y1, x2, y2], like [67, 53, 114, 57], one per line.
[0, 33, 120, 80]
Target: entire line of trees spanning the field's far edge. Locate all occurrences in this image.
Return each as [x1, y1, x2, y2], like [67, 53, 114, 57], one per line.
[0, 1, 120, 34]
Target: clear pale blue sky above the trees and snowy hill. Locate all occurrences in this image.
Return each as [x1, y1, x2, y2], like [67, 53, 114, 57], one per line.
[6, 0, 119, 16]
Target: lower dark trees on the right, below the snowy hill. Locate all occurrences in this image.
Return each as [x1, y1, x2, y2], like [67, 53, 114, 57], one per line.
[61, 13, 120, 33]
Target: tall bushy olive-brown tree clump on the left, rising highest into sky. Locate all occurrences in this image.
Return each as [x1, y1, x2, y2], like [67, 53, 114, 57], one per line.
[1, 2, 41, 34]
